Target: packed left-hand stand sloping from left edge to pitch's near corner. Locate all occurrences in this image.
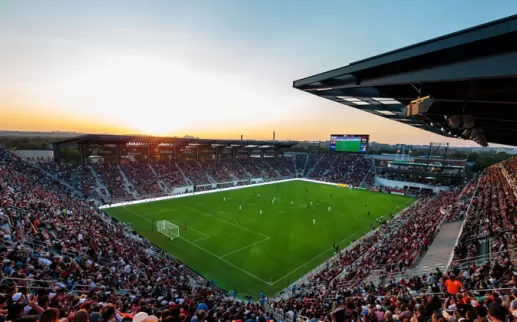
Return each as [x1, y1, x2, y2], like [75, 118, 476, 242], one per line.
[0, 150, 236, 322]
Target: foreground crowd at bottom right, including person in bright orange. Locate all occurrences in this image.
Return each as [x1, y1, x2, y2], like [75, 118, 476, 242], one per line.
[274, 261, 517, 322]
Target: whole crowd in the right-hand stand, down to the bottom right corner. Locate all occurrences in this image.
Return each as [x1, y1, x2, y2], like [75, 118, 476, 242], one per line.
[270, 166, 517, 322]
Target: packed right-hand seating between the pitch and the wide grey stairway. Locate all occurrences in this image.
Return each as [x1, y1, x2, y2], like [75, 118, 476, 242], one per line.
[290, 191, 460, 306]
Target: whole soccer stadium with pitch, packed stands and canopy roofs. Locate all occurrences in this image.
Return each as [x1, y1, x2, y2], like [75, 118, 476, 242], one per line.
[0, 5, 517, 322]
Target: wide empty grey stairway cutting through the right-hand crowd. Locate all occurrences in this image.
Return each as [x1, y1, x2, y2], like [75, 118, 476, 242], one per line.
[406, 220, 463, 277]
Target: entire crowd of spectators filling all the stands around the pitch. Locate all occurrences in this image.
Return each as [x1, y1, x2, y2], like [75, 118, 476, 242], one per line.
[6, 145, 517, 322]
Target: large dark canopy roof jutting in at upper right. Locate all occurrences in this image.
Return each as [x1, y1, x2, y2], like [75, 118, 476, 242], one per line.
[293, 15, 517, 145]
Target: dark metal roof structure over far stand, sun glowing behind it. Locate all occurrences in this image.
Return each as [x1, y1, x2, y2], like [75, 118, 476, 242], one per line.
[52, 134, 297, 164]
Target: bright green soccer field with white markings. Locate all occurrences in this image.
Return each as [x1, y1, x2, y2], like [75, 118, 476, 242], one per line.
[106, 181, 414, 298]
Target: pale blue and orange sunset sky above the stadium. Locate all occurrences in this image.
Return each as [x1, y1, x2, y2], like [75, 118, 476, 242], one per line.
[0, 0, 517, 145]
